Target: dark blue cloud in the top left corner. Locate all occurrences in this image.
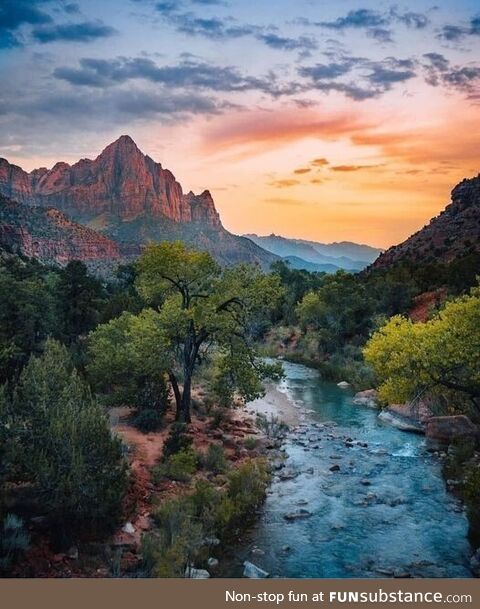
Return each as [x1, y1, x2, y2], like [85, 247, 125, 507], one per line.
[0, 0, 52, 48]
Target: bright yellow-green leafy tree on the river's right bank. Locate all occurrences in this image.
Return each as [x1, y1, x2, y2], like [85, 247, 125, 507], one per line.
[364, 288, 480, 415]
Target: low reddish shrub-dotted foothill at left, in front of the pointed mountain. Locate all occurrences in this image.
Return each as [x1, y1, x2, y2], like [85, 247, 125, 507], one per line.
[0, 195, 130, 265]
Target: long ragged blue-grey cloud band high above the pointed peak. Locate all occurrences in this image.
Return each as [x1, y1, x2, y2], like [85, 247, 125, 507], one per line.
[53, 57, 299, 97]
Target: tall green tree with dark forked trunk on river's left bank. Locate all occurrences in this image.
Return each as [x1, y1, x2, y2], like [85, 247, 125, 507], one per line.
[133, 242, 281, 422]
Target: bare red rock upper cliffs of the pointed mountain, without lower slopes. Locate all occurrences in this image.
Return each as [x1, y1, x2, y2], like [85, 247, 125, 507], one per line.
[0, 135, 221, 227]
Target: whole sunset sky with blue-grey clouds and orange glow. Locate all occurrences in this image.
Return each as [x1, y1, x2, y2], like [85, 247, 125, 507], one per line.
[0, 0, 480, 247]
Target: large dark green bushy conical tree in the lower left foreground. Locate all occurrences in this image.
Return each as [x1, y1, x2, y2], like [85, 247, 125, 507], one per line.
[11, 339, 127, 543]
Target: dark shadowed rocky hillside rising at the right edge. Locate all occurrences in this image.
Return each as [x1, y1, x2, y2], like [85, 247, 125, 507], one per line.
[370, 175, 480, 269]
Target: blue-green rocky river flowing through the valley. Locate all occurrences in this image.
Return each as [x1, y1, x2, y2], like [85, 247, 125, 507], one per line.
[222, 363, 471, 578]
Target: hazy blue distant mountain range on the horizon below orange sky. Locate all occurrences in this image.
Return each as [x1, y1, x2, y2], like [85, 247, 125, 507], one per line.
[245, 234, 383, 273]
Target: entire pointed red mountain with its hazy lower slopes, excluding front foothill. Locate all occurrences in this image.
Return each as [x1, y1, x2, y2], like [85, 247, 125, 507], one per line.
[0, 135, 277, 268]
